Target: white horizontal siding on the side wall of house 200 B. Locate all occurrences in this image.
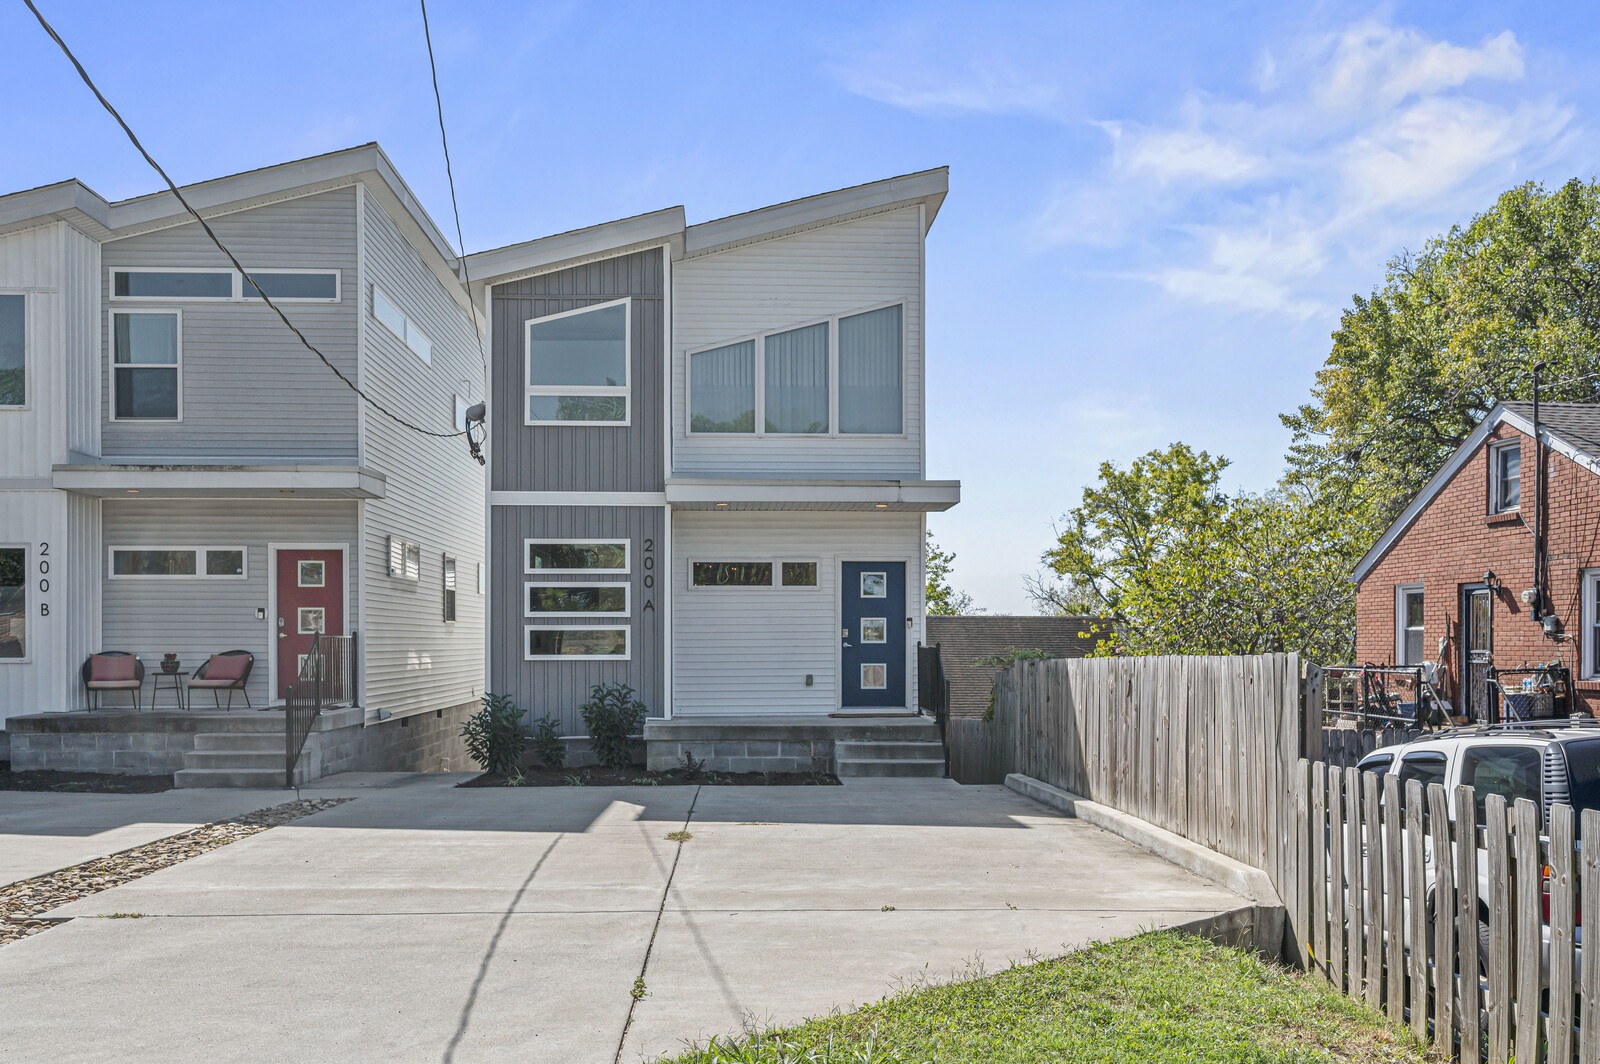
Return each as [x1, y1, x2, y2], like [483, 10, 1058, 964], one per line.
[350, 195, 486, 714]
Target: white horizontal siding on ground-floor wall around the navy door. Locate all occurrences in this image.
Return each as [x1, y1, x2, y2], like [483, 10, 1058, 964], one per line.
[672, 510, 923, 717]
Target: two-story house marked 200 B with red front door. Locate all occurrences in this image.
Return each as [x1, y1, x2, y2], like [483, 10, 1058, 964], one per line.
[0, 144, 485, 782]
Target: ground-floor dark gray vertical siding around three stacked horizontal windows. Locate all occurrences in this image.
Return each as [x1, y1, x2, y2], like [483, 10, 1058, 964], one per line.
[490, 506, 667, 734]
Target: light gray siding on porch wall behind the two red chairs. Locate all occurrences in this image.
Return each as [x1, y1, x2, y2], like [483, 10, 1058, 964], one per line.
[103, 499, 360, 709]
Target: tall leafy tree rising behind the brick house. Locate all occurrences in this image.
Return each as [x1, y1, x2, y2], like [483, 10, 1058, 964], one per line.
[1283, 179, 1600, 541]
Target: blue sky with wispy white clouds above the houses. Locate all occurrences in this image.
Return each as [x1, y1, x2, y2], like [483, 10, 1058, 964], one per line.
[0, 0, 1600, 613]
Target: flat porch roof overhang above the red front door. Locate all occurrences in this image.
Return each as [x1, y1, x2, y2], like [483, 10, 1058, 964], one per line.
[51, 464, 389, 499]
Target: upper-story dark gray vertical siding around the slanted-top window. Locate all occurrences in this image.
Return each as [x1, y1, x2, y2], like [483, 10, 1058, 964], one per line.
[490, 248, 666, 491]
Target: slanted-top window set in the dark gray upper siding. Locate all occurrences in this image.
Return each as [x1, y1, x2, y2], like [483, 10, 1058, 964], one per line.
[526, 299, 630, 426]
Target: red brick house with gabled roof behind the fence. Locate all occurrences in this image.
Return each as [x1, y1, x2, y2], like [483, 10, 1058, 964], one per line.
[1354, 403, 1600, 718]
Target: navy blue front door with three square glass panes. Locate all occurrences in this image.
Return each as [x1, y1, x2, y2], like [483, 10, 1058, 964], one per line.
[838, 562, 906, 709]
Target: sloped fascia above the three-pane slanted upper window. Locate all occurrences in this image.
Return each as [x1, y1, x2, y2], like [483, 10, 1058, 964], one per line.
[683, 166, 950, 254]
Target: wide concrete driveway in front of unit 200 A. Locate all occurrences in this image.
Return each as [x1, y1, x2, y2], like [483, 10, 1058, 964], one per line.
[0, 774, 1246, 1064]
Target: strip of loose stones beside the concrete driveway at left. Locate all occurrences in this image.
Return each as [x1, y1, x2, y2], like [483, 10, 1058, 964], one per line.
[0, 798, 354, 946]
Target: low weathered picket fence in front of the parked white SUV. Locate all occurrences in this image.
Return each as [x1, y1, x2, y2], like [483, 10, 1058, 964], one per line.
[1283, 762, 1600, 1064]
